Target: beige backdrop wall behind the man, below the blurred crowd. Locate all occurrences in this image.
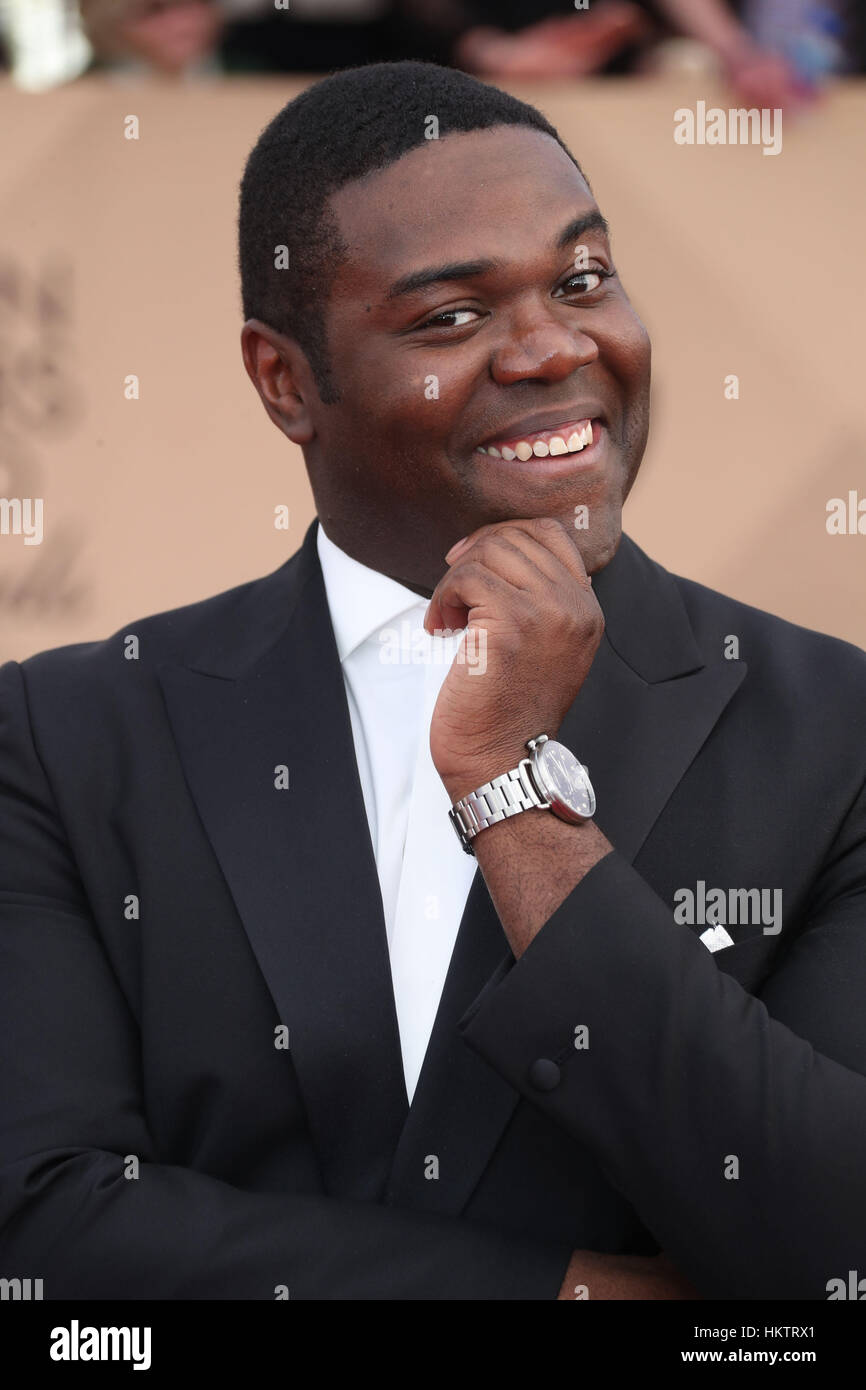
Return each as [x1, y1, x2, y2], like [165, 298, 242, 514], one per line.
[0, 78, 866, 659]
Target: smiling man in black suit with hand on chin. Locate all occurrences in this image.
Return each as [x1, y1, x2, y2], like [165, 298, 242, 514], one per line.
[0, 64, 866, 1300]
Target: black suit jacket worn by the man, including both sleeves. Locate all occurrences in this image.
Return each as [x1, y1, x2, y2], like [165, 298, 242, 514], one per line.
[0, 523, 866, 1298]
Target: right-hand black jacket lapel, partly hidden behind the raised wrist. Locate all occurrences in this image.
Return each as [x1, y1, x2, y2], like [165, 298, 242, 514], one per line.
[386, 537, 745, 1213]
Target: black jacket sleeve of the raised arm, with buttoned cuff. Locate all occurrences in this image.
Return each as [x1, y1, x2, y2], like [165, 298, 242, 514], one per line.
[460, 790, 866, 1300]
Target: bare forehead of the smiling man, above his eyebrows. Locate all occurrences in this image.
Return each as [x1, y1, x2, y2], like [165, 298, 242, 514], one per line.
[325, 126, 595, 293]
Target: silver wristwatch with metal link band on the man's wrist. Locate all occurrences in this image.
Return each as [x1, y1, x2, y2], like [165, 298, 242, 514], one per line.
[448, 734, 595, 855]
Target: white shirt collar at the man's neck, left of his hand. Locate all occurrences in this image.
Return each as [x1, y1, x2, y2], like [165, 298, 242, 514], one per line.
[316, 521, 428, 662]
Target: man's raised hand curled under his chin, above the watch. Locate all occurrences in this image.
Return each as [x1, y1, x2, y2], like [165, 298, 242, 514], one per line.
[424, 517, 605, 801]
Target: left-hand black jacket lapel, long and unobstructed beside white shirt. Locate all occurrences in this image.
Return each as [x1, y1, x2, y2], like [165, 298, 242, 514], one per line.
[160, 524, 407, 1200]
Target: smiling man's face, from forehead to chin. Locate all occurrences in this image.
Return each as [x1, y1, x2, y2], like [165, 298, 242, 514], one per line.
[304, 126, 651, 589]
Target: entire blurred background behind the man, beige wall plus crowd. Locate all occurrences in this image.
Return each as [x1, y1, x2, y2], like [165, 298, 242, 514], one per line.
[0, 0, 866, 660]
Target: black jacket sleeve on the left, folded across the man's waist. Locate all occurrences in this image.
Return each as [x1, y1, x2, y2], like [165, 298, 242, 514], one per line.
[0, 663, 571, 1300]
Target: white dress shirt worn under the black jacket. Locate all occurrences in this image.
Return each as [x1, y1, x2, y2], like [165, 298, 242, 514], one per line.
[317, 521, 477, 1102]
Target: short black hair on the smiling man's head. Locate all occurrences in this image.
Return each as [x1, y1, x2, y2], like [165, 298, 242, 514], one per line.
[238, 63, 585, 403]
